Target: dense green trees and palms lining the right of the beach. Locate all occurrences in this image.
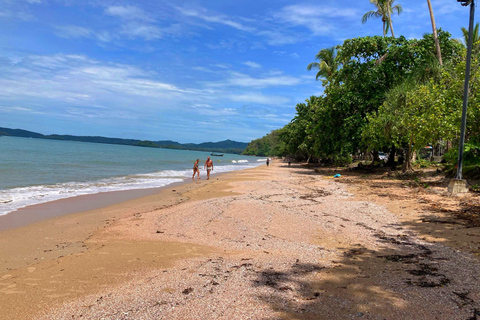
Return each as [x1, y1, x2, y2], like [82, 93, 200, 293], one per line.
[246, 0, 480, 175]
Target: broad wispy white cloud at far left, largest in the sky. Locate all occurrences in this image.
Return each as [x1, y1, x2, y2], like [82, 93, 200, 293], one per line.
[0, 54, 212, 108]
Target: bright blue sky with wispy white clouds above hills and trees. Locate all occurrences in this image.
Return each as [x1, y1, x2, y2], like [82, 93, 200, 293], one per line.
[0, 0, 480, 143]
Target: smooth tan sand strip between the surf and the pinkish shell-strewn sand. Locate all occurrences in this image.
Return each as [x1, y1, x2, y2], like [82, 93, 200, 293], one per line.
[0, 167, 258, 320]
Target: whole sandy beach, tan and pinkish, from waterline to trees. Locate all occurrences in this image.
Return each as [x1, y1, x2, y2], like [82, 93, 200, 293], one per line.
[0, 161, 480, 320]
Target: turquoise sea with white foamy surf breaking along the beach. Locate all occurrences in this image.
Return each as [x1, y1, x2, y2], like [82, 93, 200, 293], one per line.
[0, 136, 266, 215]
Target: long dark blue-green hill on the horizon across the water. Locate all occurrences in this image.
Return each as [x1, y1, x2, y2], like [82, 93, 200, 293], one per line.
[0, 127, 248, 154]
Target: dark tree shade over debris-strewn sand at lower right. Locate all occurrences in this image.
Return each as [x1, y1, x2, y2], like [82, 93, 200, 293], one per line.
[252, 164, 480, 320]
